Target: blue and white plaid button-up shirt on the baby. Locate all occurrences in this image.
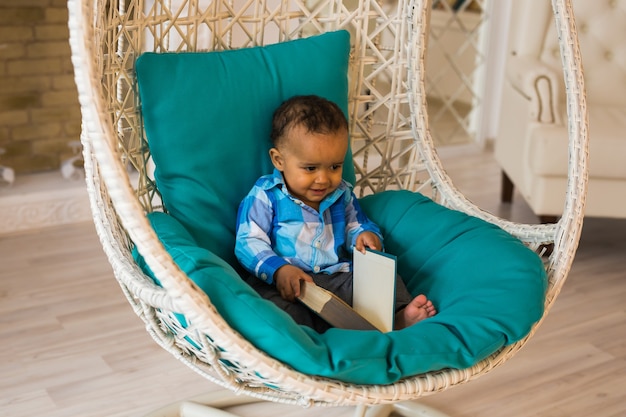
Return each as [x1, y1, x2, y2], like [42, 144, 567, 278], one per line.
[235, 170, 382, 283]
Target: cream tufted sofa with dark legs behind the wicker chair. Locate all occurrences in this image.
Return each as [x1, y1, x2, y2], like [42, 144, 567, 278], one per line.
[495, 0, 626, 222]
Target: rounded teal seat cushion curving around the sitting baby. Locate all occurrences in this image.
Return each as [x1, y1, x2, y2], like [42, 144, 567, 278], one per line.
[135, 191, 547, 384]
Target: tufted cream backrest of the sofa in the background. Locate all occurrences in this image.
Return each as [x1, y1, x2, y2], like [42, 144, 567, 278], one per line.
[511, 0, 626, 106]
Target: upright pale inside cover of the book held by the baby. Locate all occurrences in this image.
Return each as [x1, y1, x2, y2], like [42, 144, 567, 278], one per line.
[352, 249, 396, 332]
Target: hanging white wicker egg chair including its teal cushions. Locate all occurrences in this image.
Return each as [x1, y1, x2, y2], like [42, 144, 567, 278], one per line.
[68, 0, 587, 416]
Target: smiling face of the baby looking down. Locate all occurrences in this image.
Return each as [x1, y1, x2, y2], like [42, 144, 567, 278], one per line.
[270, 122, 348, 210]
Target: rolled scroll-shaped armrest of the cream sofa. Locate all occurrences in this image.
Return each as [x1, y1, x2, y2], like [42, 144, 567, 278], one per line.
[506, 56, 561, 124]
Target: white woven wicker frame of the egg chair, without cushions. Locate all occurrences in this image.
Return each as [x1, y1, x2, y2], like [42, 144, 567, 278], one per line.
[68, 0, 587, 415]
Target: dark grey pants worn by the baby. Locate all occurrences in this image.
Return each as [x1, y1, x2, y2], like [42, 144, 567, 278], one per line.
[245, 272, 413, 333]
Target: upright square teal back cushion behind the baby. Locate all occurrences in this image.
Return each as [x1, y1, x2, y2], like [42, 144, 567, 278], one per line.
[136, 31, 354, 265]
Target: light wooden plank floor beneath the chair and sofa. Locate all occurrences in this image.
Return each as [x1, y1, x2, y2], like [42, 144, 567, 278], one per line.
[0, 146, 626, 417]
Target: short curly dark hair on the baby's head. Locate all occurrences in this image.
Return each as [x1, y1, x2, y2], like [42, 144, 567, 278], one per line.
[270, 95, 348, 146]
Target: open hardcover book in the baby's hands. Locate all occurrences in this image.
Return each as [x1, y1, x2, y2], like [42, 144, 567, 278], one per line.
[299, 250, 396, 332]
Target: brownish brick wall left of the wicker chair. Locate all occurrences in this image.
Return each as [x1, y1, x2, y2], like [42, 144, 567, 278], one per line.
[0, 0, 80, 173]
